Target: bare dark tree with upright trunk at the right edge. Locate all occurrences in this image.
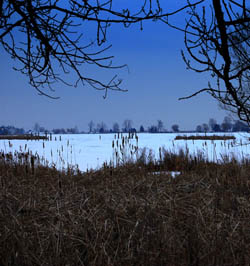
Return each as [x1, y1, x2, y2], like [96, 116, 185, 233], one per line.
[165, 0, 250, 124]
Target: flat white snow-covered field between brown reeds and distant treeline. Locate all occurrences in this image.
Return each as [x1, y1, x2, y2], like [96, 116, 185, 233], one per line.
[0, 133, 250, 171]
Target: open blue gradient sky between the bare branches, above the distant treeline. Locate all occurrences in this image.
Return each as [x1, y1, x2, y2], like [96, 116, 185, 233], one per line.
[0, 1, 230, 130]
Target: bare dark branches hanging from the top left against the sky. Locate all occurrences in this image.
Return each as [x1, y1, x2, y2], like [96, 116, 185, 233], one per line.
[0, 0, 197, 98]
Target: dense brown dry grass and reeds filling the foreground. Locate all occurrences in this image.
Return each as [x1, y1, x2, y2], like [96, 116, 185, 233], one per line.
[0, 151, 250, 266]
